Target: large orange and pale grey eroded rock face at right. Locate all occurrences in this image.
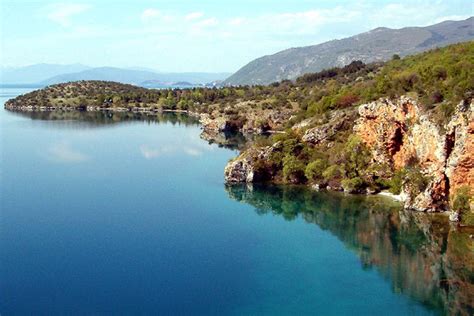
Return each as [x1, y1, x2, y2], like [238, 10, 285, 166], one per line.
[354, 97, 474, 211]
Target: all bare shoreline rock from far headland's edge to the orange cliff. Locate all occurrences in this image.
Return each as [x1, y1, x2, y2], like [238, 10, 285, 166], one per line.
[5, 96, 474, 218]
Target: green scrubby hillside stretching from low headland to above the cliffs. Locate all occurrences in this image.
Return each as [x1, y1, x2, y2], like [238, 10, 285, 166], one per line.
[8, 42, 474, 124]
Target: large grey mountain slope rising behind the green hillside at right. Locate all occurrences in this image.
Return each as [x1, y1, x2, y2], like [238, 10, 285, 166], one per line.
[223, 17, 474, 85]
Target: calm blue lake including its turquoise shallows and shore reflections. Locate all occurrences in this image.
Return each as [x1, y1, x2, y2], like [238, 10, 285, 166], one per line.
[0, 87, 474, 315]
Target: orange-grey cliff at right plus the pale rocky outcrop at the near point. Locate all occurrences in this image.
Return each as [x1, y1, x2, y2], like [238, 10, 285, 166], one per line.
[225, 96, 474, 212]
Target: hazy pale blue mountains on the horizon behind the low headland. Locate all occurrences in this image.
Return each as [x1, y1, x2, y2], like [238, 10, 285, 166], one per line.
[0, 64, 230, 88]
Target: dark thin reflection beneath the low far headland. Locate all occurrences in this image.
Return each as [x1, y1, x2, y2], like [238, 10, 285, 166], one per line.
[7, 111, 199, 127]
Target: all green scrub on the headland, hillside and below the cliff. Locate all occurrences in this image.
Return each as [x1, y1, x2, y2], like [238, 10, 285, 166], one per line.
[7, 42, 474, 200]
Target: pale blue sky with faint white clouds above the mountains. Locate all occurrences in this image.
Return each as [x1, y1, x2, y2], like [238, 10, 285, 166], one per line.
[0, 0, 473, 72]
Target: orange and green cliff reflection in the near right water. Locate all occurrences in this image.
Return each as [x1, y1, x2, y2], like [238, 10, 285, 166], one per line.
[226, 185, 474, 315]
